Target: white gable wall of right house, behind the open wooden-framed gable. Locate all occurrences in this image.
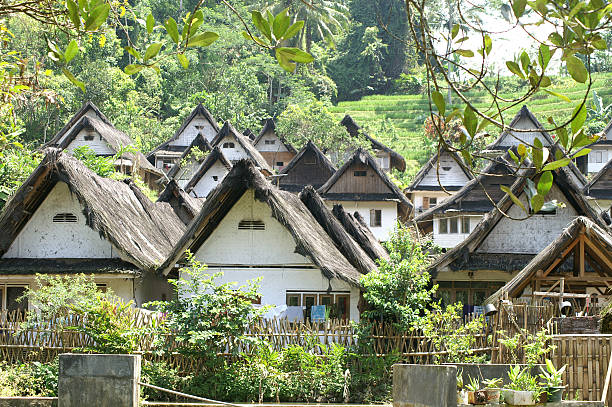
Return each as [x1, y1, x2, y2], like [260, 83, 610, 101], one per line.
[476, 184, 578, 254]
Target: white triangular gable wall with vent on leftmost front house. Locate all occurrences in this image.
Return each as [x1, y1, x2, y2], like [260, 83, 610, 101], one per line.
[3, 182, 119, 258]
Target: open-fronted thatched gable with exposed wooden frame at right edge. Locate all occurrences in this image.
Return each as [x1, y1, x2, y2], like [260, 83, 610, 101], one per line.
[487, 216, 612, 302]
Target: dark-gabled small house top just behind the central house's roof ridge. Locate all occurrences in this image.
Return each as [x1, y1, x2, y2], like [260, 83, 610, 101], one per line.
[279, 141, 336, 192]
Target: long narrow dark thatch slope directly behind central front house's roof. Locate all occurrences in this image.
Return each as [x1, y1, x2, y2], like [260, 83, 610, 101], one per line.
[299, 186, 377, 274]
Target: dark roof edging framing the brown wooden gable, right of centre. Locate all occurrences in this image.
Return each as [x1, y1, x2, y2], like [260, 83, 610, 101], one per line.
[318, 148, 413, 215]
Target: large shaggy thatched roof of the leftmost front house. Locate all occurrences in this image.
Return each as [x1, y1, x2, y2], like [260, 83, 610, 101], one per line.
[0, 149, 185, 271]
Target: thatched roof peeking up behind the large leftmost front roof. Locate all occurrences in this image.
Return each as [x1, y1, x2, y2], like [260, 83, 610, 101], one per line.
[57, 116, 161, 174]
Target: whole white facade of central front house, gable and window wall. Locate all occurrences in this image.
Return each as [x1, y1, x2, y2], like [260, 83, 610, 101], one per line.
[194, 190, 359, 320]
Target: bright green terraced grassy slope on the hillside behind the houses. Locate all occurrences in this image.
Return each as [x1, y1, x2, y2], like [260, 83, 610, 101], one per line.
[332, 73, 612, 178]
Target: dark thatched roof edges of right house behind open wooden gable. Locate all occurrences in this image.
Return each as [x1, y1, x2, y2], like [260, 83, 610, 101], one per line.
[429, 161, 606, 276]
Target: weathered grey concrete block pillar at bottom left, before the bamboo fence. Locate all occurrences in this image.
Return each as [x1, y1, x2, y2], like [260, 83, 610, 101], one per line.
[58, 353, 140, 407]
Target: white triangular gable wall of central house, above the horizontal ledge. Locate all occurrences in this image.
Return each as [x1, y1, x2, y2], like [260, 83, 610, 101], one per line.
[195, 190, 310, 266]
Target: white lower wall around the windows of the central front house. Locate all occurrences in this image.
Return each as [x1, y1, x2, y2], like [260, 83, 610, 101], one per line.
[183, 266, 359, 321]
